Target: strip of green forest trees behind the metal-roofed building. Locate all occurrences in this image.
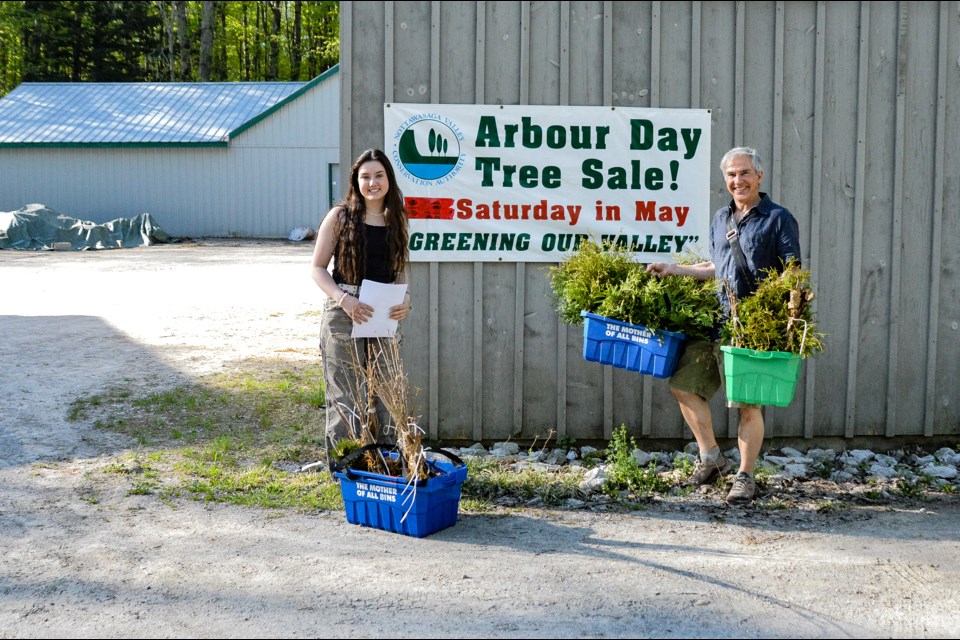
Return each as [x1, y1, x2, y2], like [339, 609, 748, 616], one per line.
[0, 0, 340, 95]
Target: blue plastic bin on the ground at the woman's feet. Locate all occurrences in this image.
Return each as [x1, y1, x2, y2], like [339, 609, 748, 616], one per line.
[333, 454, 467, 538]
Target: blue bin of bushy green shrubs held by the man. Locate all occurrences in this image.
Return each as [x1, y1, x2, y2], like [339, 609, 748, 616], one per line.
[550, 240, 720, 378]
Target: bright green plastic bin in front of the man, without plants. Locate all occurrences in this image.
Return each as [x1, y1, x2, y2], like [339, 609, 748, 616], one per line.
[720, 345, 800, 407]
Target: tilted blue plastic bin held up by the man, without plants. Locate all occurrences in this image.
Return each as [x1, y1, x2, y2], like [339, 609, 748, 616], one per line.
[580, 311, 685, 378]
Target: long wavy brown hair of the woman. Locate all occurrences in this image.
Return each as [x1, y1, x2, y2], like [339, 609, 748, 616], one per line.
[334, 149, 409, 284]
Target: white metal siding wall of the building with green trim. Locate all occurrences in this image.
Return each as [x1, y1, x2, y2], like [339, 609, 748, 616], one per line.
[0, 77, 340, 238]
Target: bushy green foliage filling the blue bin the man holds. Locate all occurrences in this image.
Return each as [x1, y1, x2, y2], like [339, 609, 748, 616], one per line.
[550, 240, 720, 339]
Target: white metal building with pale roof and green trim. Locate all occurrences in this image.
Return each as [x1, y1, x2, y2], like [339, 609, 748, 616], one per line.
[0, 66, 340, 238]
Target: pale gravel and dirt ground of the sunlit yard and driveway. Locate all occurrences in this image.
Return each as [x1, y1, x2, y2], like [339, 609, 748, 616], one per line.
[0, 241, 960, 638]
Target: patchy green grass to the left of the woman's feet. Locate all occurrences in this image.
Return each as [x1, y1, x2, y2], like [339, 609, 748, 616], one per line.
[67, 360, 343, 511]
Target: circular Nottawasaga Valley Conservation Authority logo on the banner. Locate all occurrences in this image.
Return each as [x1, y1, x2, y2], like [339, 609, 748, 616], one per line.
[393, 113, 463, 184]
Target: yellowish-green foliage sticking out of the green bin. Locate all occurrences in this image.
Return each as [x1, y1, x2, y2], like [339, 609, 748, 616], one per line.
[722, 265, 824, 358]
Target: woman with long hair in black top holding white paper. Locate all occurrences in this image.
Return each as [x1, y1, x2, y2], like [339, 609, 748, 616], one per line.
[311, 149, 410, 461]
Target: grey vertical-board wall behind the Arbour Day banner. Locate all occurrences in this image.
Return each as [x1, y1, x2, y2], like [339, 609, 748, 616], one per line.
[340, 1, 960, 441]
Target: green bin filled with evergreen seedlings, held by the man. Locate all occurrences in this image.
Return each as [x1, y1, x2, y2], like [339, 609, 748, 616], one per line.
[720, 264, 824, 407]
